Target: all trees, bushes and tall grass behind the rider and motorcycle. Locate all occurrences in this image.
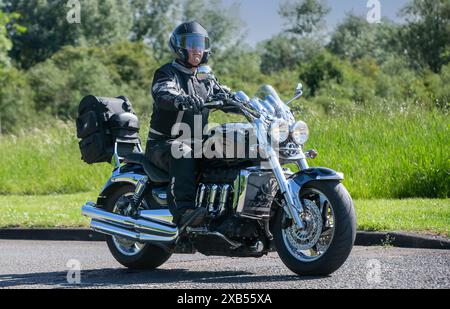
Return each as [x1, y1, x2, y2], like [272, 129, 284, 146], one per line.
[0, 0, 450, 202]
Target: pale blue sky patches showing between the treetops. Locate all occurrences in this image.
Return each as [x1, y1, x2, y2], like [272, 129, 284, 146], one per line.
[222, 0, 410, 46]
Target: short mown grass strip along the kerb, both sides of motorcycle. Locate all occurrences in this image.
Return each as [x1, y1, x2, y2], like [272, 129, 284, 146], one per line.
[0, 192, 450, 237]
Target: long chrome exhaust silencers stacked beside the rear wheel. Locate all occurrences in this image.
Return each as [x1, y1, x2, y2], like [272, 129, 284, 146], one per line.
[82, 203, 178, 243]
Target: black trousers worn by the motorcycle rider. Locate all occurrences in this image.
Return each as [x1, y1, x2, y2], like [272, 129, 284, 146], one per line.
[145, 139, 198, 220]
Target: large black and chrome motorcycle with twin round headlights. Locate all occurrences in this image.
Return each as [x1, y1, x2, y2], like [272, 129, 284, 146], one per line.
[82, 66, 356, 276]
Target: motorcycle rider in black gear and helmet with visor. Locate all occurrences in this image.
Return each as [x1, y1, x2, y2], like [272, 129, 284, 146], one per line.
[146, 21, 238, 227]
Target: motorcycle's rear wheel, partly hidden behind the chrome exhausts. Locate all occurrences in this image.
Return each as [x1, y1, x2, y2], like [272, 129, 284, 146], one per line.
[104, 185, 172, 270]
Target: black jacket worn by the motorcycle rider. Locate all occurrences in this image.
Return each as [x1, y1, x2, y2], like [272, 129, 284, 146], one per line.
[149, 61, 237, 139]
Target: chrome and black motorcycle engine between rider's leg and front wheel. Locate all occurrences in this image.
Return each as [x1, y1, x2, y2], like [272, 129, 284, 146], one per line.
[153, 167, 278, 257]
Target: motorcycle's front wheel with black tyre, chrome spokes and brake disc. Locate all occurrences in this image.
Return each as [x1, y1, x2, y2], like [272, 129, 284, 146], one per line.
[273, 181, 356, 276]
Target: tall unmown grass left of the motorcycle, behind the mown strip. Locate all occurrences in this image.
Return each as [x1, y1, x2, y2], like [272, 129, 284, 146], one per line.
[0, 120, 111, 195]
